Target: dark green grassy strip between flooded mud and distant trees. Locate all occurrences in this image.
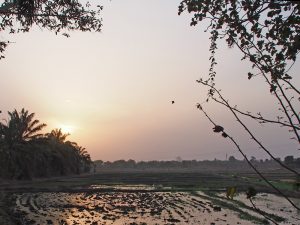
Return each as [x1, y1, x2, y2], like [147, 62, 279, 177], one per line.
[0, 172, 297, 198]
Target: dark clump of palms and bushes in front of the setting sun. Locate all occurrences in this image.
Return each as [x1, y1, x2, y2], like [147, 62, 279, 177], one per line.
[0, 108, 91, 179]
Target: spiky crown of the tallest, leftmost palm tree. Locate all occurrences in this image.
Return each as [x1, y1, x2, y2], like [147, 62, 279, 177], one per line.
[0, 108, 46, 147]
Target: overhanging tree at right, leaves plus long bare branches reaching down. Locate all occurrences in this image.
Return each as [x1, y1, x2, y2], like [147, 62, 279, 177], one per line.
[178, 0, 300, 209]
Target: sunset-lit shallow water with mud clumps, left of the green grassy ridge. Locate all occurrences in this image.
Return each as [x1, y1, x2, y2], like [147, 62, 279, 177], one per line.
[15, 185, 300, 225]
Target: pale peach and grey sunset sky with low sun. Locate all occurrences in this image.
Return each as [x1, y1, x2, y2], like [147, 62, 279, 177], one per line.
[0, 0, 300, 161]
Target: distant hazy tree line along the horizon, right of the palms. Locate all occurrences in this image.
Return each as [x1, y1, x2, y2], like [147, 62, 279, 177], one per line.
[93, 156, 300, 172]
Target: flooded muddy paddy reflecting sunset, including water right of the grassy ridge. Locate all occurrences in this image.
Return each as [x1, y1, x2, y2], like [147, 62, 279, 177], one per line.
[14, 186, 300, 225]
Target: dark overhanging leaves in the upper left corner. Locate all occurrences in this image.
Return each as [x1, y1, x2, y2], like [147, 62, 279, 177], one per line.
[0, 0, 103, 59]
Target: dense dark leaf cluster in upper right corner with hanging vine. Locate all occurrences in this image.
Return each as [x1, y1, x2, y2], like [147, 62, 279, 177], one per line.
[178, 0, 300, 95]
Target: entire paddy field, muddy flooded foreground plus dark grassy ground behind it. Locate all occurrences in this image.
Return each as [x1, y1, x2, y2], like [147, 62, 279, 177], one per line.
[0, 173, 300, 225]
